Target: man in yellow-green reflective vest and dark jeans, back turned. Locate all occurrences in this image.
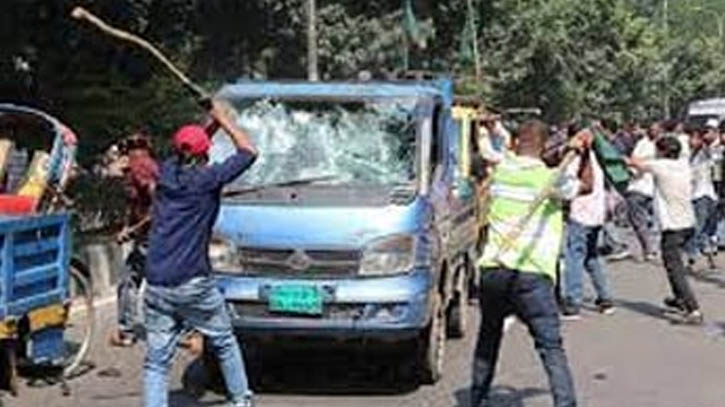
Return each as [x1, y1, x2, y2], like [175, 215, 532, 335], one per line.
[471, 121, 592, 407]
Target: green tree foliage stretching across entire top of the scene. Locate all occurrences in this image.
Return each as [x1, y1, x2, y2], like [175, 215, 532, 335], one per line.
[0, 0, 725, 151]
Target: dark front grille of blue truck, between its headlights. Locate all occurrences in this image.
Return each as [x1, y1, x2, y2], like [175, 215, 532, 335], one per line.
[239, 247, 361, 278]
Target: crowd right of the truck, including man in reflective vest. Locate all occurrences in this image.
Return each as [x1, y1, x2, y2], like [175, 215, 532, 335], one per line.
[471, 116, 725, 407]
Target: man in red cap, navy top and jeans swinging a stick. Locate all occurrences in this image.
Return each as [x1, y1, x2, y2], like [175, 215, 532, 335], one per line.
[144, 102, 257, 407]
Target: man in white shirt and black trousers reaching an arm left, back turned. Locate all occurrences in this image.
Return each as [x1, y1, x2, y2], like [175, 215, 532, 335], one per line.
[628, 137, 703, 324]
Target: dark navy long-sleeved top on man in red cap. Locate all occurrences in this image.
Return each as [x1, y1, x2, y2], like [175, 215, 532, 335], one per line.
[146, 151, 255, 287]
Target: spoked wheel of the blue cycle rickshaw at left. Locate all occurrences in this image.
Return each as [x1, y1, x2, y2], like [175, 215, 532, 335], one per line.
[63, 265, 95, 378]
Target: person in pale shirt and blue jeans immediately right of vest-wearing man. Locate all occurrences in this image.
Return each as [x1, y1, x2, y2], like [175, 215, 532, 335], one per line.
[561, 138, 614, 319]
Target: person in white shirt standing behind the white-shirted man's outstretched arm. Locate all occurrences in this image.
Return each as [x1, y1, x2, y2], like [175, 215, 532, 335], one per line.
[625, 123, 662, 261]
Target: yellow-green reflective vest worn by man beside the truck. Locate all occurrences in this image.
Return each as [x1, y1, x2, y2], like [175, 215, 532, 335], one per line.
[478, 154, 576, 282]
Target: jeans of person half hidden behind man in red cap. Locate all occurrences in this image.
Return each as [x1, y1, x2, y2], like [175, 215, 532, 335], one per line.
[116, 242, 148, 337]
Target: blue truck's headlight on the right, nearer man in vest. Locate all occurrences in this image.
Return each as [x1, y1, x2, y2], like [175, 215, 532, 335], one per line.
[360, 235, 416, 276]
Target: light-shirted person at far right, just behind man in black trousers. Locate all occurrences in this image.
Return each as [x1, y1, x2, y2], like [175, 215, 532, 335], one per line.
[687, 123, 717, 266]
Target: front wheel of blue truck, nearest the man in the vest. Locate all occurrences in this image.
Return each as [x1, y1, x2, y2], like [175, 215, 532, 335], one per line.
[418, 294, 446, 384]
